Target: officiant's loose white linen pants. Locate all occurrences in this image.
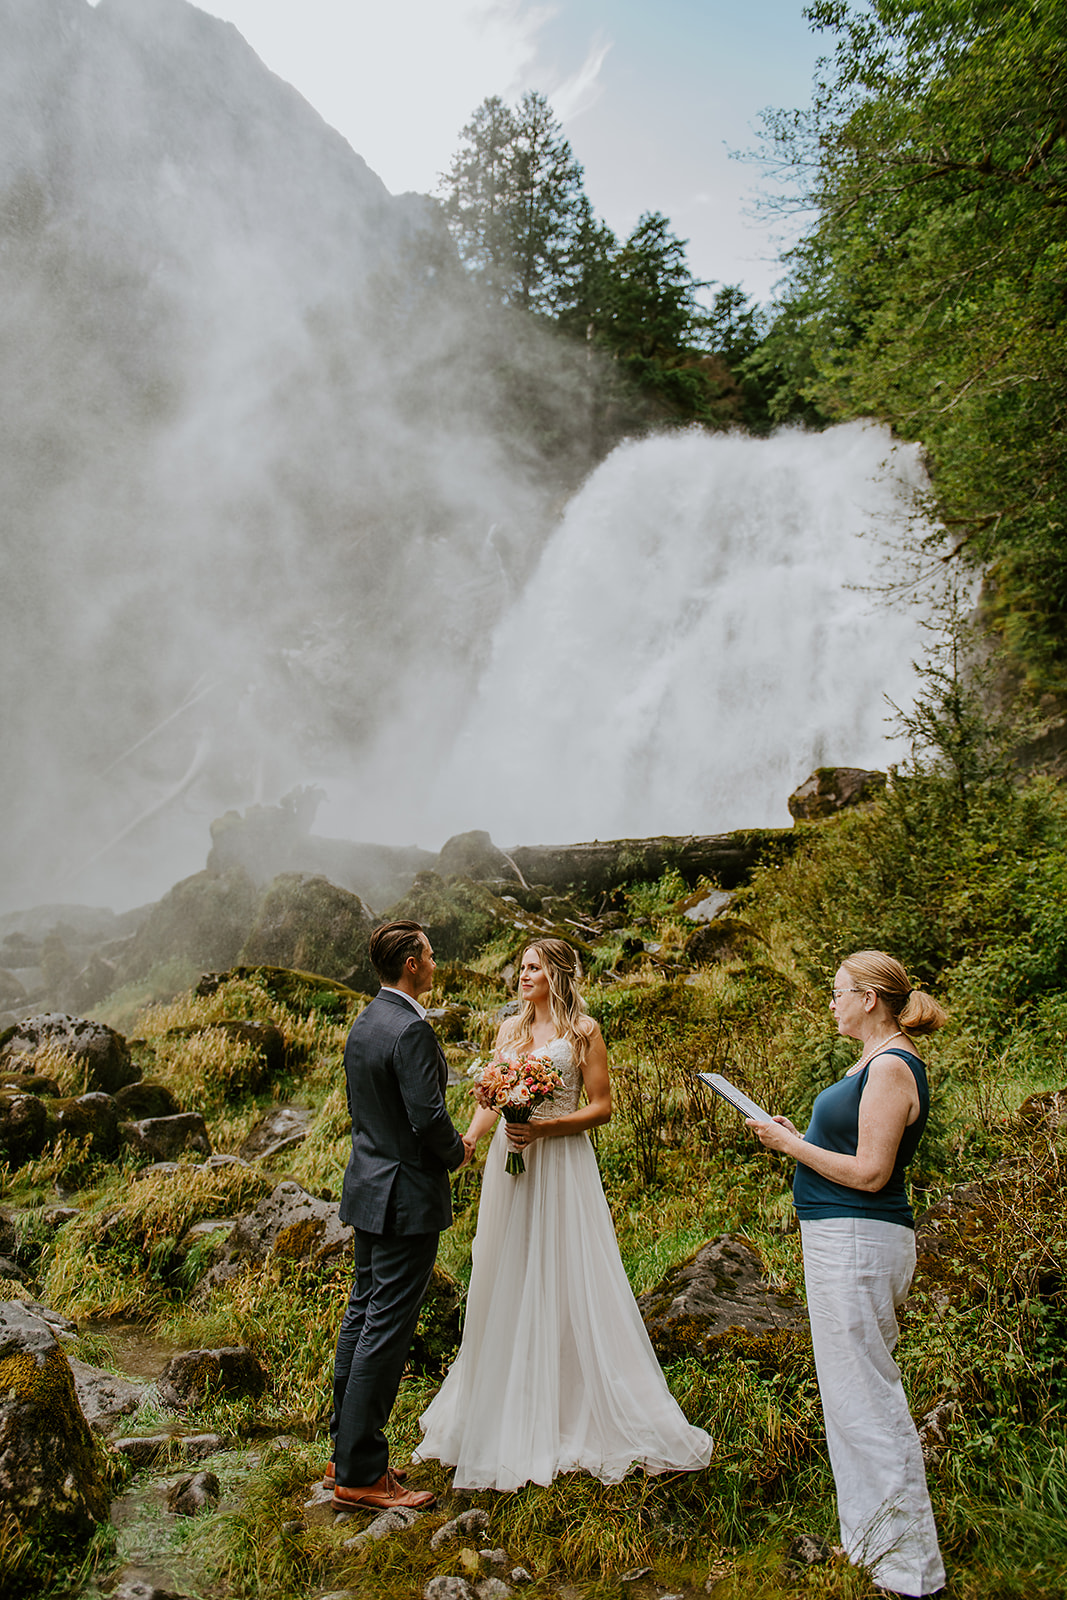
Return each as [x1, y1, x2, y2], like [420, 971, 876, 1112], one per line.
[800, 1216, 945, 1595]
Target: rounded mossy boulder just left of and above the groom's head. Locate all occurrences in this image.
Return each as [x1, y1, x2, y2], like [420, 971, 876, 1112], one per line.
[240, 872, 378, 994]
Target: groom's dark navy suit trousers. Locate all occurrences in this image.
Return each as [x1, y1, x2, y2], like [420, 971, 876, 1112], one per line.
[330, 1227, 440, 1488]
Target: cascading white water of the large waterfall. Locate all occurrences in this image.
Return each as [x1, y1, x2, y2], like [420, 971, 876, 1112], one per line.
[406, 424, 923, 843]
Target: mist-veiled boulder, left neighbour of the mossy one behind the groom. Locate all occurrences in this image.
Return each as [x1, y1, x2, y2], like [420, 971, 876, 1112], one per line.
[118, 867, 258, 982]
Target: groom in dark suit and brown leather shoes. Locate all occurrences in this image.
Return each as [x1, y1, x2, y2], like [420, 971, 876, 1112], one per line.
[325, 922, 470, 1510]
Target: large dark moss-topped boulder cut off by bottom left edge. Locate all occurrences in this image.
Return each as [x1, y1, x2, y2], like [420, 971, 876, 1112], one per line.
[0, 1301, 109, 1538]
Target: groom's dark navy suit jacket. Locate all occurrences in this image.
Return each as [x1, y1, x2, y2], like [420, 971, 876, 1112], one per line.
[341, 994, 464, 1234]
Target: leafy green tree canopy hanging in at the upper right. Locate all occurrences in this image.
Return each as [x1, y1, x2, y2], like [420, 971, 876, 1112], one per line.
[764, 0, 1067, 686]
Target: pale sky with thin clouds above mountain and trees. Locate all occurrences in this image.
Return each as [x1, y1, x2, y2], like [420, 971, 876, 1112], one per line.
[189, 0, 825, 301]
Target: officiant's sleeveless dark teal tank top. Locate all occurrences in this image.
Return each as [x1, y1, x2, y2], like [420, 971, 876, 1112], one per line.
[793, 1050, 929, 1227]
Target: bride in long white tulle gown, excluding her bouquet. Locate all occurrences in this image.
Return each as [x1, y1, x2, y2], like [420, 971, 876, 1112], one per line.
[418, 939, 712, 1490]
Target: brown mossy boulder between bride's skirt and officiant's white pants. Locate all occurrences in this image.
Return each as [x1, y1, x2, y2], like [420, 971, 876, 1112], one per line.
[637, 1234, 808, 1360]
